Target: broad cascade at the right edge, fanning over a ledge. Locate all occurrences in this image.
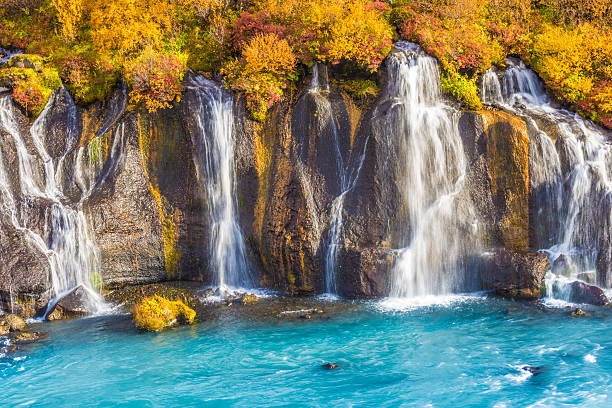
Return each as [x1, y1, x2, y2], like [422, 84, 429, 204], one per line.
[483, 59, 612, 300]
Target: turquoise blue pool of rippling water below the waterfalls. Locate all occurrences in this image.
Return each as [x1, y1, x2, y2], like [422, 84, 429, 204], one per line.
[0, 297, 612, 407]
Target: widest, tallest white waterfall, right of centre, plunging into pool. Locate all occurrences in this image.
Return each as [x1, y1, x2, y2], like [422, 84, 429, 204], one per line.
[386, 42, 473, 297]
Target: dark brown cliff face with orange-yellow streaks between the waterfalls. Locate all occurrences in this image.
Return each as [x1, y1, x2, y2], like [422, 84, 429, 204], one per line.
[0, 49, 610, 314]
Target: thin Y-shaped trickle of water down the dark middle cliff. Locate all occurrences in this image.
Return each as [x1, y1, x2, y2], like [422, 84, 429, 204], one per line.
[309, 63, 367, 295]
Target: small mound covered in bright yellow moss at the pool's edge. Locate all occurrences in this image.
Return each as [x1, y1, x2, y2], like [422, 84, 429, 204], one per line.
[134, 295, 196, 331]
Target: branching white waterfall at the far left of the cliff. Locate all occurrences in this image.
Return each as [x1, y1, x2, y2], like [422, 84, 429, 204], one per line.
[0, 93, 105, 313]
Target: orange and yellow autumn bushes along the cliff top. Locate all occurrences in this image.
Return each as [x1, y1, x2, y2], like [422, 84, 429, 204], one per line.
[0, 0, 612, 127]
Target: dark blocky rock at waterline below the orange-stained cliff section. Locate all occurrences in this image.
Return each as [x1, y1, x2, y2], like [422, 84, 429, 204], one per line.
[481, 249, 550, 300]
